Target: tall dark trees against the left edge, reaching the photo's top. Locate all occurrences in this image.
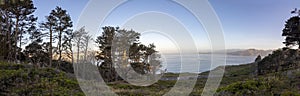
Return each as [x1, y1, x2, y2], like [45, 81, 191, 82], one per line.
[0, 0, 37, 61]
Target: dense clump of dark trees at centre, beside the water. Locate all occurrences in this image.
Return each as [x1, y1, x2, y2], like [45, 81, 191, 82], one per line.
[96, 26, 161, 82]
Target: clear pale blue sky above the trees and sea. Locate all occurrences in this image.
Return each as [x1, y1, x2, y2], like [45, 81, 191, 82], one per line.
[34, 0, 300, 51]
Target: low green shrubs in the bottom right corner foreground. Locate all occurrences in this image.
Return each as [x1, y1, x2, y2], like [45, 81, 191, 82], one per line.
[217, 76, 300, 96]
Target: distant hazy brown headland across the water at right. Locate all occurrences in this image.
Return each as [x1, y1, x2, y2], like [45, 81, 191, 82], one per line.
[227, 49, 272, 56]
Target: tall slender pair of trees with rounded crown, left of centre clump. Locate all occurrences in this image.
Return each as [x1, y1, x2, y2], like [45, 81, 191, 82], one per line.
[40, 6, 73, 67]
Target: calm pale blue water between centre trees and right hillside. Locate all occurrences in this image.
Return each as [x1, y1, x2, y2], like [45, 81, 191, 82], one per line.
[162, 54, 256, 73]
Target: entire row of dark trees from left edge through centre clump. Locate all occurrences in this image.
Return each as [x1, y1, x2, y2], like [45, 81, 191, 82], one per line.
[0, 0, 161, 81]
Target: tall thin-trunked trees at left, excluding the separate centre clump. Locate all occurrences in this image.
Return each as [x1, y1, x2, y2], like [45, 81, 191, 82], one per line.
[0, 0, 76, 67]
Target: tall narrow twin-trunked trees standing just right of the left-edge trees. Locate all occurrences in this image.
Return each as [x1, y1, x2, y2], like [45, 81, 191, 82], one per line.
[42, 6, 73, 67]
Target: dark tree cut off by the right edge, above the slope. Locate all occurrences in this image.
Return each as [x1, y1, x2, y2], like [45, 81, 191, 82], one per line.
[282, 9, 300, 49]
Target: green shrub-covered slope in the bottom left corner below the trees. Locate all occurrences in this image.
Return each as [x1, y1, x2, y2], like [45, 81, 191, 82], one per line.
[0, 62, 84, 96]
